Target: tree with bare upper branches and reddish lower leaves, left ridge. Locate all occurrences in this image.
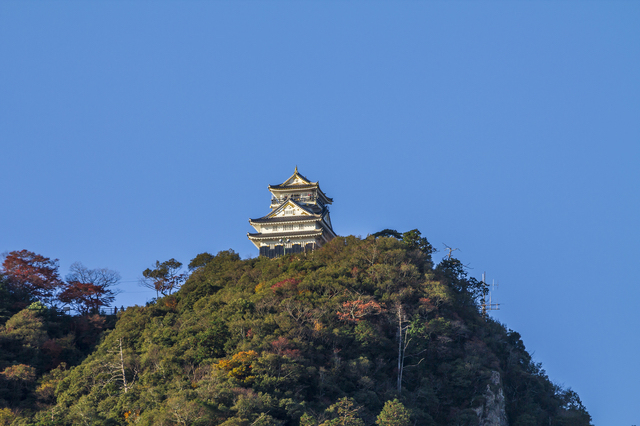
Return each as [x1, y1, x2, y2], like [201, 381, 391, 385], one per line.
[58, 262, 120, 315]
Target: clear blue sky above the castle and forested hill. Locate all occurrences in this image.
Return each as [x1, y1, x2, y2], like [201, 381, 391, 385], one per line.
[0, 1, 640, 425]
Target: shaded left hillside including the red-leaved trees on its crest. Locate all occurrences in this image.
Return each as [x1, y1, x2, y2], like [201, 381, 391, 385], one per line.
[0, 250, 119, 426]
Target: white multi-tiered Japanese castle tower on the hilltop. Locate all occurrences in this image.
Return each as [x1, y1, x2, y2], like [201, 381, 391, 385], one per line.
[247, 166, 336, 258]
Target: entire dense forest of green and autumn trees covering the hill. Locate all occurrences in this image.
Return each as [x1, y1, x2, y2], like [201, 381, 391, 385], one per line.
[0, 230, 591, 426]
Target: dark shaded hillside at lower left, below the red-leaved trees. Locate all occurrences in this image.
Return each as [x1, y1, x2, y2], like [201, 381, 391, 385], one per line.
[0, 300, 116, 426]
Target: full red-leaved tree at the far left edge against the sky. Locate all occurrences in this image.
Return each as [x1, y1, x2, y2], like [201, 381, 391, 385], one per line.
[2, 250, 64, 304]
